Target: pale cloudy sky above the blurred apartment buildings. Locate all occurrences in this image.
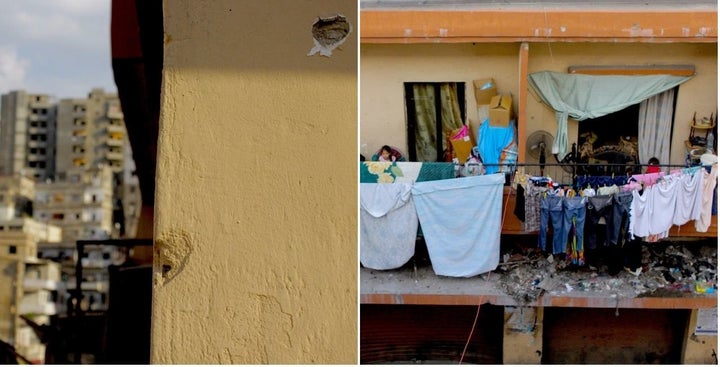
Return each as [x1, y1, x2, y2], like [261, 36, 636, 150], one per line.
[0, 0, 117, 99]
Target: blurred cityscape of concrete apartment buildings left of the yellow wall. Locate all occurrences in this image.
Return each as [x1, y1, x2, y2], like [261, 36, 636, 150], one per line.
[0, 89, 152, 363]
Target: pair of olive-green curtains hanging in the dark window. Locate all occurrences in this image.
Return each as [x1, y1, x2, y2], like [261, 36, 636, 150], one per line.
[413, 83, 463, 162]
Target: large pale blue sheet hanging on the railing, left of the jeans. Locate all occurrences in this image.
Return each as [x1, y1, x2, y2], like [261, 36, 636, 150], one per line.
[412, 173, 505, 277]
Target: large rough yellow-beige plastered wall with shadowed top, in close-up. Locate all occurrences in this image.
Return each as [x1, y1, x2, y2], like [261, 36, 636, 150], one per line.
[151, 0, 358, 364]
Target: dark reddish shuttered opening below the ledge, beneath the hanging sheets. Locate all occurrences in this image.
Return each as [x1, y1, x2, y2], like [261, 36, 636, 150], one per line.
[360, 305, 504, 364]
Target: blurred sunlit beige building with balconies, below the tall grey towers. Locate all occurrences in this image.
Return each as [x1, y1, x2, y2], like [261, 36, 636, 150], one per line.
[0, 174, 64, 363]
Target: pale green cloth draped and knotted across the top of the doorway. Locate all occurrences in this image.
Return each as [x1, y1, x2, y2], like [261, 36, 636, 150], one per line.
[528, 71, 691, 157]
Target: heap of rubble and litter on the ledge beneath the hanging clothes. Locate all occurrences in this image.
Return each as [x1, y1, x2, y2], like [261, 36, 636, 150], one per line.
[494, 242, 717, 305]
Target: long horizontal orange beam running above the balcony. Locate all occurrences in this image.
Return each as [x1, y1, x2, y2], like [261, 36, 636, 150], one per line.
[360, 8, 718, 43]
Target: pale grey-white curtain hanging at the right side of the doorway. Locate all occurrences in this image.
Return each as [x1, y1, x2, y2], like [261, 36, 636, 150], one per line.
[638, 89, 675, 164]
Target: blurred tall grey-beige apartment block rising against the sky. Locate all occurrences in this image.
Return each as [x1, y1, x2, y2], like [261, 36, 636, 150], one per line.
[0, 88, 141, 242]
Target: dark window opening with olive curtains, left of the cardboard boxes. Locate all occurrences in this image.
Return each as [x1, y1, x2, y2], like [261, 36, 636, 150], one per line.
[405, 82, 466, 162]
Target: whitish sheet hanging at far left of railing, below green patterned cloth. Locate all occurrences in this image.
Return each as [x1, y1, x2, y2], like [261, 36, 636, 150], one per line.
[360, 183, 418, 270]
